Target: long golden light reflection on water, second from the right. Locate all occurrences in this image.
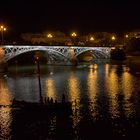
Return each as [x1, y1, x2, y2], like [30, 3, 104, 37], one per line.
[106, 66, 119, 118]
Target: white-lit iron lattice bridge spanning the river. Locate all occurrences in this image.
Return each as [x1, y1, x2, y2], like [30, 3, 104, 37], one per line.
[1, 45, 111, 61]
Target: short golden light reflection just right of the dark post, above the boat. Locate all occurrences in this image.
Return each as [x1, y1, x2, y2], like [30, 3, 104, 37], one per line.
[46, 78, 56, 99]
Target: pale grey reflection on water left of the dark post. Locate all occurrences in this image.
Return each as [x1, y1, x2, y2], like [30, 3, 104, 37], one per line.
[7, 75, 39, 102]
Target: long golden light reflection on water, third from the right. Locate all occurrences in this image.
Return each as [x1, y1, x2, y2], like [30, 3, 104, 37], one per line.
[87, 69, 97, 120]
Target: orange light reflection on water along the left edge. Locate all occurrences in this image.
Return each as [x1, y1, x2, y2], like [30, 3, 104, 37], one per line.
[0, 79, 12, 139]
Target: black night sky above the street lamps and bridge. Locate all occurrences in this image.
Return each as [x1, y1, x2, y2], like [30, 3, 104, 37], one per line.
[0, 0, 140, 35]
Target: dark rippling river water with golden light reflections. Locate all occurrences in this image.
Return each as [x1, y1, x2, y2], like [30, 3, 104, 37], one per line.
[0, 64, 140, 140]
